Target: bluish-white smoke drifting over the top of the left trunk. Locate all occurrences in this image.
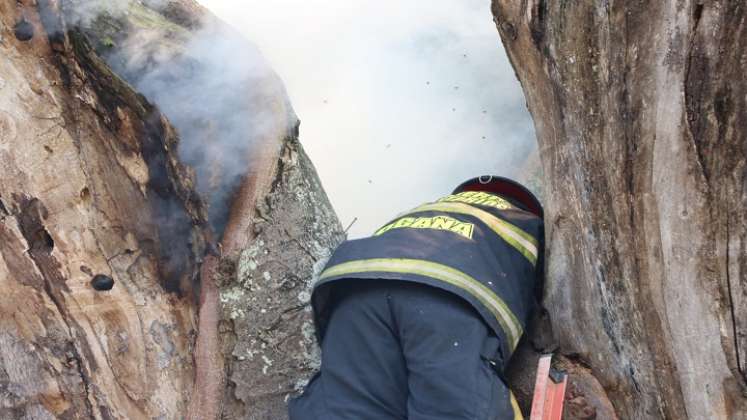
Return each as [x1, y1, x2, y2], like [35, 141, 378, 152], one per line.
[68, 0, 283, 236]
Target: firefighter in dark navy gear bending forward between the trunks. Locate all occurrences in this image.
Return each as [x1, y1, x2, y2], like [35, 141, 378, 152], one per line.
[289, 176, 543, 420]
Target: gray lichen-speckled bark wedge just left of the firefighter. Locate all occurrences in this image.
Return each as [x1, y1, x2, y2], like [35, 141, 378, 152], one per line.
[221, 138, 344, 419]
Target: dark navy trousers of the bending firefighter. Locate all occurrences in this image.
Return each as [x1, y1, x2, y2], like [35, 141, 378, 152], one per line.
[289, 280, 515, 420]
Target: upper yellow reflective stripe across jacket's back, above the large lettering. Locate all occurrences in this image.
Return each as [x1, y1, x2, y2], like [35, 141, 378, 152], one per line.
[408, 203, 537, 264]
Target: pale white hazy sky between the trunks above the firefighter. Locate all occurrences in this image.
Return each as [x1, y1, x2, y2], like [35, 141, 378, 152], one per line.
[200, 0, 535, 237]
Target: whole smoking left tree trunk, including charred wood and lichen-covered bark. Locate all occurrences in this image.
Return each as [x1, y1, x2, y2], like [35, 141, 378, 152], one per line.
[0, 0, 342, 419]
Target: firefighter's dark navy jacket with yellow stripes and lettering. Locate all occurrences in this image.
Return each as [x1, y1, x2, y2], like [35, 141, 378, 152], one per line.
[312, 191, 543, 360]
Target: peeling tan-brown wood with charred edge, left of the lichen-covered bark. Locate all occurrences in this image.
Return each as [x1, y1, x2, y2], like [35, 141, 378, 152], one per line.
[0, 1, 205, 419]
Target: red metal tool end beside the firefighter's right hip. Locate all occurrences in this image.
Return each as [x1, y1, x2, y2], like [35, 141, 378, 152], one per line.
[529, 354, 568, 420]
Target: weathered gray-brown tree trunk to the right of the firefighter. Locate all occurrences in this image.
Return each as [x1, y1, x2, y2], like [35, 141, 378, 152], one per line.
[492, 0, 747, 419]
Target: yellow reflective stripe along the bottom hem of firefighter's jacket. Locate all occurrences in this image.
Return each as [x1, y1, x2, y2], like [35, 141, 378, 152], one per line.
[319, 258, 523, 351]
